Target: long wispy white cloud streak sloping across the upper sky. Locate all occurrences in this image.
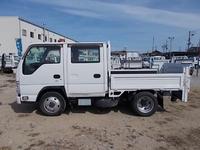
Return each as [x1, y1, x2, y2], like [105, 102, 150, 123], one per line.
[28, 0, 200, 29]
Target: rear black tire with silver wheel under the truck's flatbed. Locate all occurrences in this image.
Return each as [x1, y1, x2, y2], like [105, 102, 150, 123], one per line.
[131, 92, 158, 117]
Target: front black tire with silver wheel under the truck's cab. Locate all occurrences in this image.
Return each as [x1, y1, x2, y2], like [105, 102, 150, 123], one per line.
[39, 92, 66, 116]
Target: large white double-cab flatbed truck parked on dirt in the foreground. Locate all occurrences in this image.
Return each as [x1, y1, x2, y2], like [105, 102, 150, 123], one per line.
[16, 42, 190, 116]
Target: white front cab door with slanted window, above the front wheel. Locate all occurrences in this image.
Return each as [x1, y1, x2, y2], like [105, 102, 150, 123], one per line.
[20, 44, 64, 101]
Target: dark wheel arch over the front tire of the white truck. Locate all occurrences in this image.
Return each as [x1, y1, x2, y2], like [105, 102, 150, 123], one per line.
[36, 86, 67, 102]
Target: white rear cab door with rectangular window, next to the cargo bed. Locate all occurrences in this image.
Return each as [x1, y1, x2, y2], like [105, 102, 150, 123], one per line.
[66, 43, 105, 97]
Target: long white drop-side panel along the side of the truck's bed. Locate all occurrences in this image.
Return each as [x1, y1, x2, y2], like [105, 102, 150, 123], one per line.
[111, 74, 183, 90]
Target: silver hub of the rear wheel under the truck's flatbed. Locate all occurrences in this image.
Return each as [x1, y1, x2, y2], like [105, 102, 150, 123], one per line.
[137, 96, 154, 113]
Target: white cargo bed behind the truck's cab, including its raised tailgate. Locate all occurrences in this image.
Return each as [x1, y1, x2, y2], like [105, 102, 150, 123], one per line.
[110, 69, 190, 102]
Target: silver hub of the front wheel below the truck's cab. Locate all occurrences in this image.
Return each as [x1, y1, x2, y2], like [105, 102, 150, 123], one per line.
[44, 97, 60, 113]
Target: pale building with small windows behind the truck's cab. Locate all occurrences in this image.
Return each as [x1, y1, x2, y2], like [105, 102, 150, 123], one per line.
[0, 16, 76, 56]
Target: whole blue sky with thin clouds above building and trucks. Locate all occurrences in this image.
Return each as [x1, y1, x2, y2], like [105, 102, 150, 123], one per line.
[0, 0, 200, 52]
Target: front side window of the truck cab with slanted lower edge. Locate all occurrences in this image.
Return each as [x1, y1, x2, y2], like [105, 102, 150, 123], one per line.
[23, 46, 60, 75]
